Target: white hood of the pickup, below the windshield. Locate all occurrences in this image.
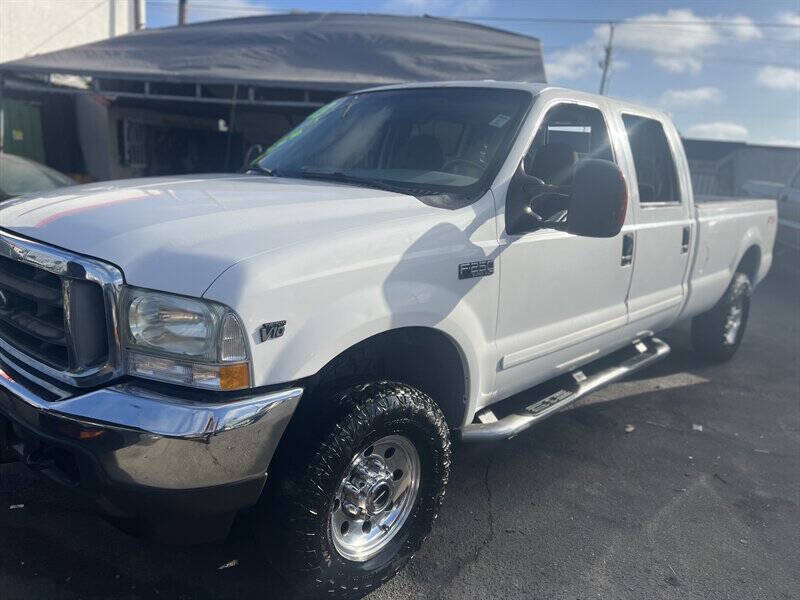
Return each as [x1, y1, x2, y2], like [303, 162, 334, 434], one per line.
[0, 175, 438, 296]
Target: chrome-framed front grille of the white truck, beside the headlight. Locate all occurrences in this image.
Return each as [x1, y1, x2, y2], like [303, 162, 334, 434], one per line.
[0, 231, 117, 386]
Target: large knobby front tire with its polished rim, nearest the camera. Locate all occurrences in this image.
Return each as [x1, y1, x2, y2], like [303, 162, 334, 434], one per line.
[260, 382, 451, 599]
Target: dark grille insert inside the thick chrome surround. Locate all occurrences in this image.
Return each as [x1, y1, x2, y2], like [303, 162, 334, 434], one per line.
[0, 256, 70, 369]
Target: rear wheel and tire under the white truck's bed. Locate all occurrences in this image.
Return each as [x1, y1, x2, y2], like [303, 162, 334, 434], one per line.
[692, 273, 752, 362]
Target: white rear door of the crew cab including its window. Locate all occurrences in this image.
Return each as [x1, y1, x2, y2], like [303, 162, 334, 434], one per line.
[619, 111, 696, 337]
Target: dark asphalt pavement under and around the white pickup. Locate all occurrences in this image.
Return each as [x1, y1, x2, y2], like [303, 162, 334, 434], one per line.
[0, 246, 800, 600]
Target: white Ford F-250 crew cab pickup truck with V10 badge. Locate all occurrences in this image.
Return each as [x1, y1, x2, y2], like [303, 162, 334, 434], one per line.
[0, 82, 776, 598]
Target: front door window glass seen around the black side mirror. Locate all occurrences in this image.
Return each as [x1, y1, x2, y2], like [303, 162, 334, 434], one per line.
[523, 104, 614, 221]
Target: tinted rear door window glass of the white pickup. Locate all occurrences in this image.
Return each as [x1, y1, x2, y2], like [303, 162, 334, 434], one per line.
[622, 115, 681, 204]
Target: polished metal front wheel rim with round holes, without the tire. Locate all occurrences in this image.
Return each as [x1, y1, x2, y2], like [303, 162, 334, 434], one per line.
[329, 435, 420, 562]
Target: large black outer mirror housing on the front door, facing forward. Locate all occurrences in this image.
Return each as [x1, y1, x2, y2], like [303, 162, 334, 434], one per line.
[566, 158, 628, 238]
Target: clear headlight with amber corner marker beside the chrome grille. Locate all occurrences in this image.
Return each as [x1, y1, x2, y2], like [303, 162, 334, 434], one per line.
[122, 288, 250, 390]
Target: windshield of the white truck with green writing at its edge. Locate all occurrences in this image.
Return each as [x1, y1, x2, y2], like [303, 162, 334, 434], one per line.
[254, 88, 532, 200]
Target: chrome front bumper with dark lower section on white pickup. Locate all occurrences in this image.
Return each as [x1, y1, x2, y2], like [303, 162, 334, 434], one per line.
[0, 369, 303, 519]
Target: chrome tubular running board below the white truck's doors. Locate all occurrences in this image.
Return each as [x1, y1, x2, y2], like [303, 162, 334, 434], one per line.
[461, 337, 670, 442]
